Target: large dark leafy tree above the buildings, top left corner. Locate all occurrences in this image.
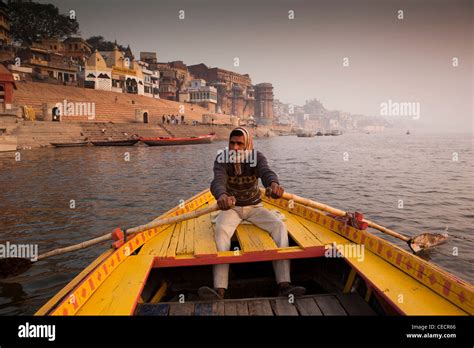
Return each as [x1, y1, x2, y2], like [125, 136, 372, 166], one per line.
[8, 2, 79, 45]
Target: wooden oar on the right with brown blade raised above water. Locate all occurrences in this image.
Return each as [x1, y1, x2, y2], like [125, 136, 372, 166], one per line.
[276, 192, 448, 253]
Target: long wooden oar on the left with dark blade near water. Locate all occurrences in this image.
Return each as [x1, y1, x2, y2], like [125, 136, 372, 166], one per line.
[0, 203, 219, 279]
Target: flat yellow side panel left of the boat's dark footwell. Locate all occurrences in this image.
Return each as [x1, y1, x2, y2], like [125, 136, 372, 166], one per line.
[77, 255, 154, 315]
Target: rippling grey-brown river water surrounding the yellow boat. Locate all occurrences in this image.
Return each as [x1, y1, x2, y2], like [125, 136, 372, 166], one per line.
[0, 133, 474, 315]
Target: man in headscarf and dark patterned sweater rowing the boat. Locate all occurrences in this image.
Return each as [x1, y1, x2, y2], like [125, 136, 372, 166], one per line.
[198, 127, 306, 299]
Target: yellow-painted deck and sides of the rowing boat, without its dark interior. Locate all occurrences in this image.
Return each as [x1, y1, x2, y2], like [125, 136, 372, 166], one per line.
[36, 190, 474, 315]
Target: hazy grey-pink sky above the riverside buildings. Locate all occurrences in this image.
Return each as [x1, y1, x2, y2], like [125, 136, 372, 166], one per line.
[42, 0, 474, 131]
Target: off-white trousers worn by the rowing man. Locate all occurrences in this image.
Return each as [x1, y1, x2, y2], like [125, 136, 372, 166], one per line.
[213, 203, 290, 289]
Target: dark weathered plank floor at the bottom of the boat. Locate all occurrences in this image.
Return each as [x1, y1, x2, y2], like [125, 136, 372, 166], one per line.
[135, 294, 376, 316]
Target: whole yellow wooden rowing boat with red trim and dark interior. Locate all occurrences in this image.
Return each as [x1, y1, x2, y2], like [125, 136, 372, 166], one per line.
[36, 190, 474, 315]
